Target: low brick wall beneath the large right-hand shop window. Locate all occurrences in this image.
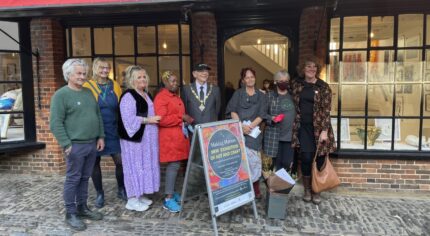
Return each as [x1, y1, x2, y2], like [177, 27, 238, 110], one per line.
[331, 158, 430, 192]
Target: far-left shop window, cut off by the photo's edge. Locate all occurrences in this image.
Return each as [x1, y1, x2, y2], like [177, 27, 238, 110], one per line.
[0, 21, 35, 145]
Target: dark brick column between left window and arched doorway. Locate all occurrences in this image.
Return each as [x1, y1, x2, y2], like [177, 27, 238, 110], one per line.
[191, 12, 218, 84]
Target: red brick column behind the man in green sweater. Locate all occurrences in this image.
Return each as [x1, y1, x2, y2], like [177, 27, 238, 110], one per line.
[30, 18, 66, 172]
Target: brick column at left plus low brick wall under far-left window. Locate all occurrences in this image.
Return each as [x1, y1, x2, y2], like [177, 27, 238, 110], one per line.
[0, 18, 65, 174]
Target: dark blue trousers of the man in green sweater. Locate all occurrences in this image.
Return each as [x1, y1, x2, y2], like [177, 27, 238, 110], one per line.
[64, 142, 97, 214]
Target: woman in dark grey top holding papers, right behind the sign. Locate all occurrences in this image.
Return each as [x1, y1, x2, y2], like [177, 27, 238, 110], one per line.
[226, 68, 267, 199]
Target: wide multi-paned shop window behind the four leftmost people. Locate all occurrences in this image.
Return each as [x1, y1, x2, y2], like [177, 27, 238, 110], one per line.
[65, 24, 191, 95]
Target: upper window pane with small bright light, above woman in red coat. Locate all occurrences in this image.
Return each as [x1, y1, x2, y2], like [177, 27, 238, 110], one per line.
[158, 25, 179, 54]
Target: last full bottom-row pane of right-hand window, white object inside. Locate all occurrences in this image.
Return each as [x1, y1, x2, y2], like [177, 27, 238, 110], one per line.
[394, 119, 420, 151]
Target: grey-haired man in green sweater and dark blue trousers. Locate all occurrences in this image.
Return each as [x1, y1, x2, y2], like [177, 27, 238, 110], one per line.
[50, 59, 104, 230]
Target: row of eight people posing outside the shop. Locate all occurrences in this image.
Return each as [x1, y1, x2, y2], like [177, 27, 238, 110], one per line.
[50, 55, 335, 230]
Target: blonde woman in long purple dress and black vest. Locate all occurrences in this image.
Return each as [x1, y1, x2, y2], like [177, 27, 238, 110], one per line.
[118, 66, 160, 211]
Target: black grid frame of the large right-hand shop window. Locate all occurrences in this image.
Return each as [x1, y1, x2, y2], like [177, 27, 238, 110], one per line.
[326, 12, 430, 157]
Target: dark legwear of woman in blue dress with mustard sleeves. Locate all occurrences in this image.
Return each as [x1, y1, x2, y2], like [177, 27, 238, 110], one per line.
[91, 153, 124, 193]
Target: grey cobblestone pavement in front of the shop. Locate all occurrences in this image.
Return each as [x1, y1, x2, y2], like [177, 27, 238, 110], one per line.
[0, 174, 430, 236]
